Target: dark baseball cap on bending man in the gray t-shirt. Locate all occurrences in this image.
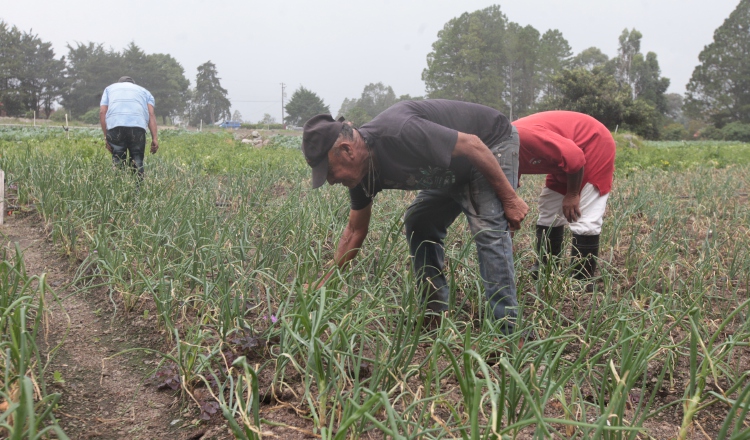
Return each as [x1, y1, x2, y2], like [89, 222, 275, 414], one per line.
[302, 115, 344, 188]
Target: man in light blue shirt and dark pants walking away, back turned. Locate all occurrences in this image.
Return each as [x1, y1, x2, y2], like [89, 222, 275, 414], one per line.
[99, 76, 159, 179]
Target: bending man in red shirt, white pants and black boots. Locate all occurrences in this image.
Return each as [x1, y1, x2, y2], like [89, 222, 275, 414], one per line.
[513, 111, 615, 279]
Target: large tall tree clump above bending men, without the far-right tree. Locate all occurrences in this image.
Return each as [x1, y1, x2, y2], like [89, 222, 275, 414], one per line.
[422, 6, 669, 138]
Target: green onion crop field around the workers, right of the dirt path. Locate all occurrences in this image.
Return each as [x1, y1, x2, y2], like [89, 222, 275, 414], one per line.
[0, 125, 750, 439]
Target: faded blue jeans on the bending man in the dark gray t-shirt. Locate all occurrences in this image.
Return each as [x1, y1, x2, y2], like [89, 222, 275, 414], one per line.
[404, 128, 519, 331]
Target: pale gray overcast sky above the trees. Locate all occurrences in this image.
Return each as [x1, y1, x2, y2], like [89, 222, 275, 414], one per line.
[0, 0, 739, 122]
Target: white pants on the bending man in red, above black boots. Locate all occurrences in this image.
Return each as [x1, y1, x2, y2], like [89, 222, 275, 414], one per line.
[536, 183, 609, 235]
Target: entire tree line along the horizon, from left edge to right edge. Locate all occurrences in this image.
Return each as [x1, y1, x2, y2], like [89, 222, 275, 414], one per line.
[0, 0, 750, 138]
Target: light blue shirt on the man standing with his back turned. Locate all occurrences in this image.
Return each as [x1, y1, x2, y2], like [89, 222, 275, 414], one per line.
[99, 82, 155, 130]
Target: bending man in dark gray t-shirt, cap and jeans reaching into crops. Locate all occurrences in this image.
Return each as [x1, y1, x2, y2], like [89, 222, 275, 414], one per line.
[302, 99, 529, 333]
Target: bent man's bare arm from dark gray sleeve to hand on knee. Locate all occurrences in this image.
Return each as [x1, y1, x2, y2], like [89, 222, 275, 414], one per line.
[453, 132, 529, 230]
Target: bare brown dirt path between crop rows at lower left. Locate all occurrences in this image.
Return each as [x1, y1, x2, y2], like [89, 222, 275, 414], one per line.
[0, 212, 228, 440]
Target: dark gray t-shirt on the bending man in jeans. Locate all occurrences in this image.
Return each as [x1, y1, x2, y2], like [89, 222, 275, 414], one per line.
[349, 99, 512, 210]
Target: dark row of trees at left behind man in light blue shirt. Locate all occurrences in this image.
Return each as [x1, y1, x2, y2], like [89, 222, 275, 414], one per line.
[0, 21, 231, 125]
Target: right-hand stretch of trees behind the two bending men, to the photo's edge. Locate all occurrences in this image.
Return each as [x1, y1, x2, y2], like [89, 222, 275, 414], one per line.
[285, 0, 750, 141]
